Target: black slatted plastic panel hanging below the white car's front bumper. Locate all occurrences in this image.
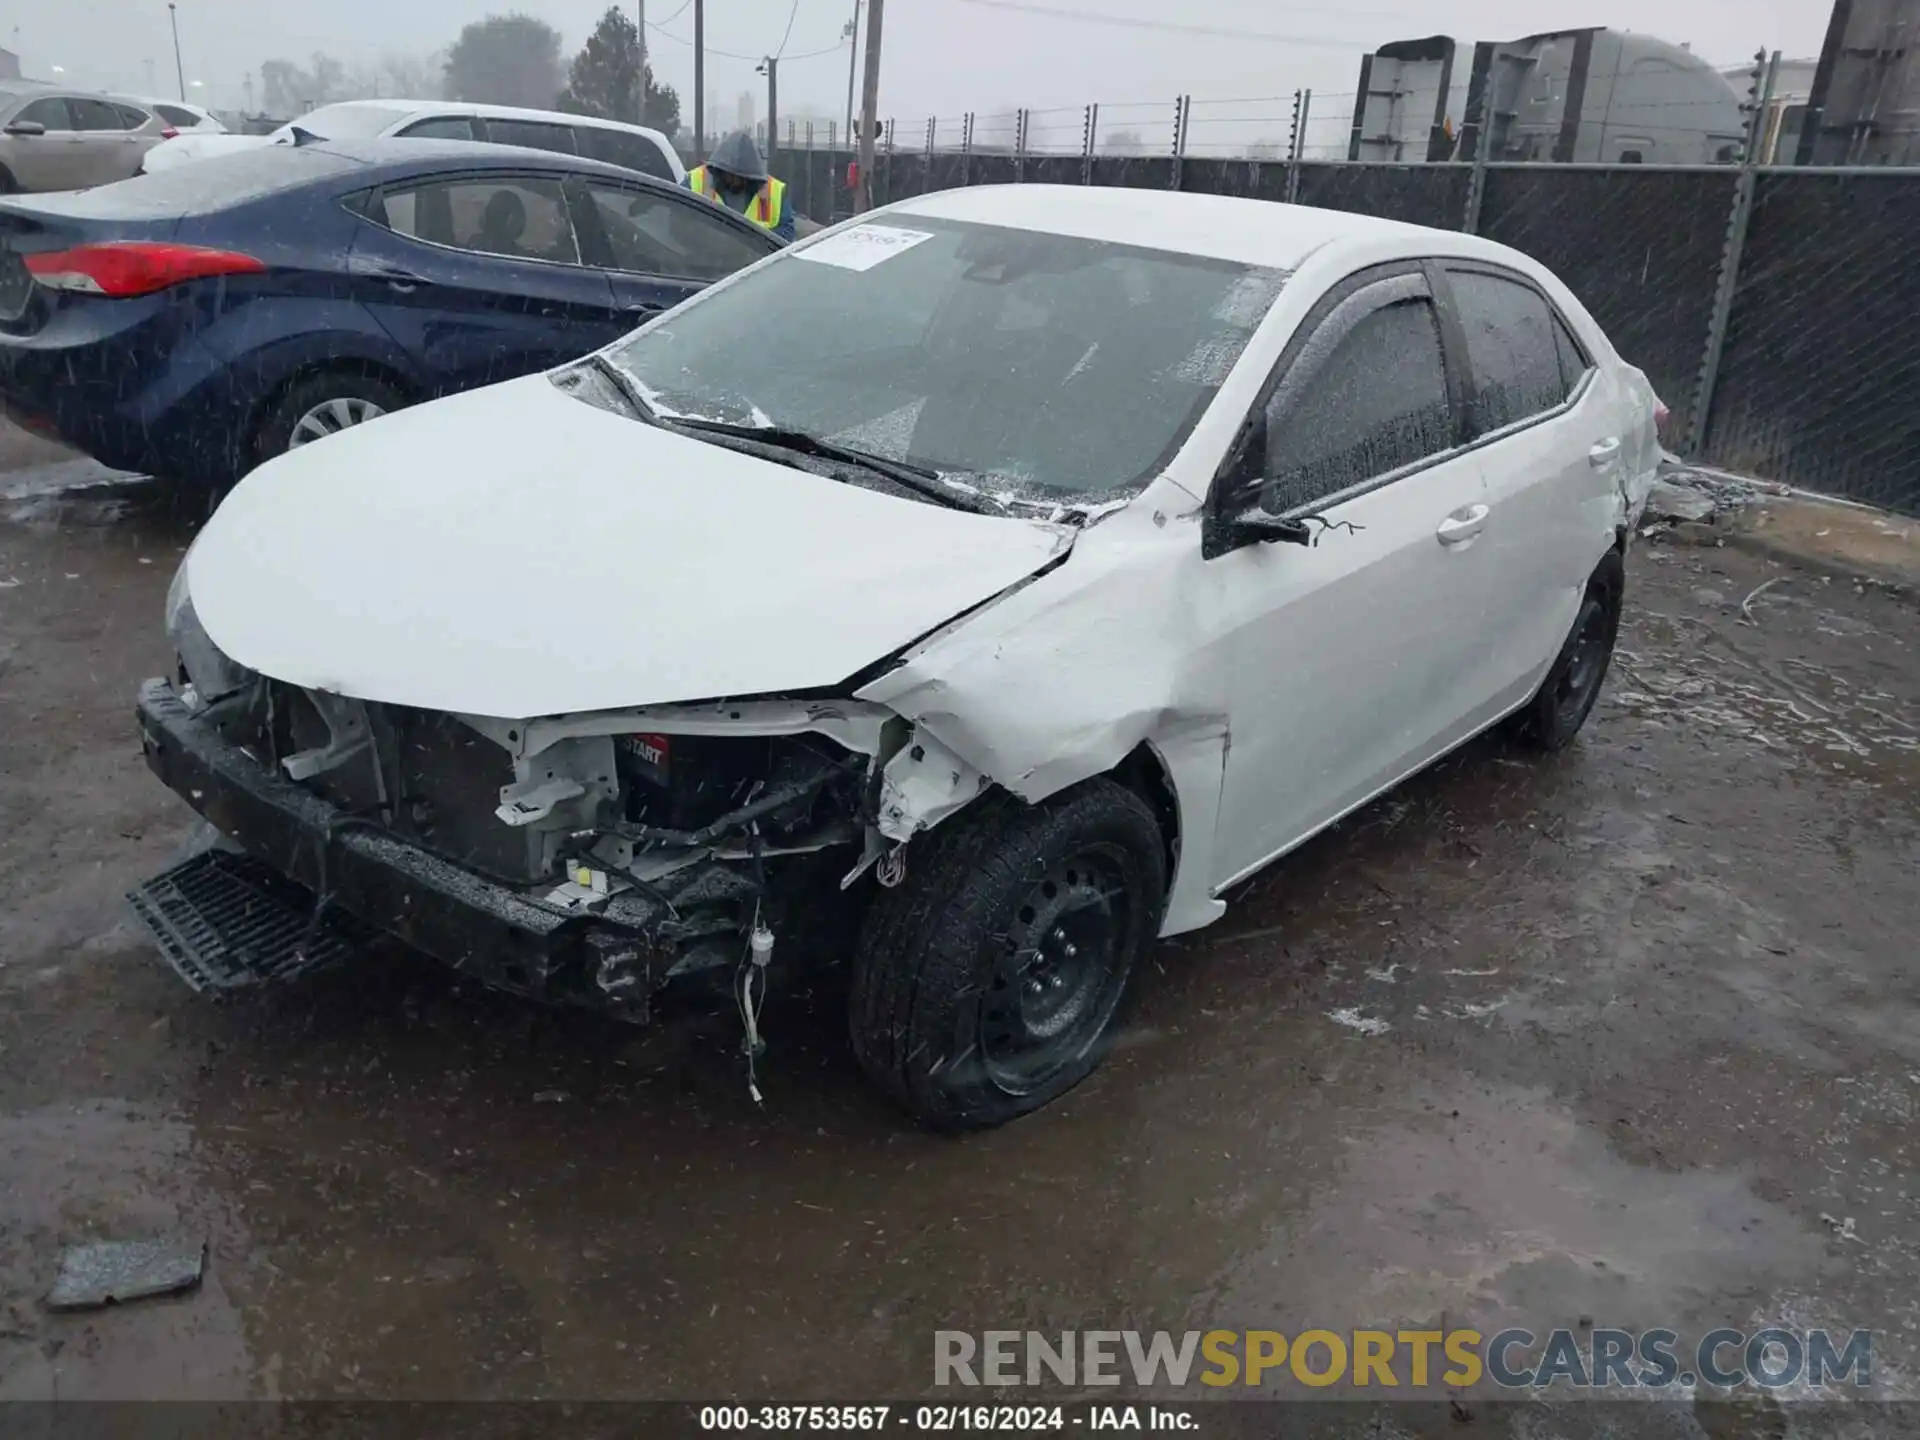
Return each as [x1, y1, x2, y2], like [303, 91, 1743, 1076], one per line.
[127, 851, 378, 993]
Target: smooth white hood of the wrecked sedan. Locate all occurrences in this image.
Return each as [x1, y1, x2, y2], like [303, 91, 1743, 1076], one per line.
[186, 376, 1071, 718]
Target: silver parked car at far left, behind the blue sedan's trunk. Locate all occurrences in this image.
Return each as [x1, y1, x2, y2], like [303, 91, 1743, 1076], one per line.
[0, 83, 175, 194]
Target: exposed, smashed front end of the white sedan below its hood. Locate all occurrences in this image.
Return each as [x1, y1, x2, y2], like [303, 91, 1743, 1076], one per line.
[132, 668, 924, 1020]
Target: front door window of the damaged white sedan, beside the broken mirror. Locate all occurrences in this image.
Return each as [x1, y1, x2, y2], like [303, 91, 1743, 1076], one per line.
[1265, 296, 1453, 511]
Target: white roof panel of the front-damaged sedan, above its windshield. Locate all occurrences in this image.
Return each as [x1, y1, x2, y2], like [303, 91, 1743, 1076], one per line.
[885, 184, 1475, 271]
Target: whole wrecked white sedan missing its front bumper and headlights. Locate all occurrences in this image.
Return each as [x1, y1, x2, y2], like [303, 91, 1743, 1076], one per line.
[134, 186, 1659, 1129]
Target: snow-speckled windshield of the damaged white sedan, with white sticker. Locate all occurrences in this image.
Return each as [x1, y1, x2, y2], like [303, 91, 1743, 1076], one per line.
[607, 215, 1284, 503]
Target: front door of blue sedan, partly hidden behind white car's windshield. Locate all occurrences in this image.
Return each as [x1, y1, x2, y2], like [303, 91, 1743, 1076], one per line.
[572, 175, 780, 340]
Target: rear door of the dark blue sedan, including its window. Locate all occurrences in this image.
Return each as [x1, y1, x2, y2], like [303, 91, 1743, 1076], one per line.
[348, 171, 626, 394]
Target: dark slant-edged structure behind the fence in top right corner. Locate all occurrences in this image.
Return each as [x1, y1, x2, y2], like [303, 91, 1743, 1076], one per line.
[1795, 0, 1920, 165]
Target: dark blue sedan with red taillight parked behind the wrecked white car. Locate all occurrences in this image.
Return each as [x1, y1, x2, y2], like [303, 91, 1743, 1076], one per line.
[0, 140, 778, 488]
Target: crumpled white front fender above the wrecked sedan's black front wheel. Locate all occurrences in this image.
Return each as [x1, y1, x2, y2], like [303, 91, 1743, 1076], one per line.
[858, 505, 1229, 935]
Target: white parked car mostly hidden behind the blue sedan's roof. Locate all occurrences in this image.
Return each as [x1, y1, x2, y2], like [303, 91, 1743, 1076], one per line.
[140, 100, 687, 184]
